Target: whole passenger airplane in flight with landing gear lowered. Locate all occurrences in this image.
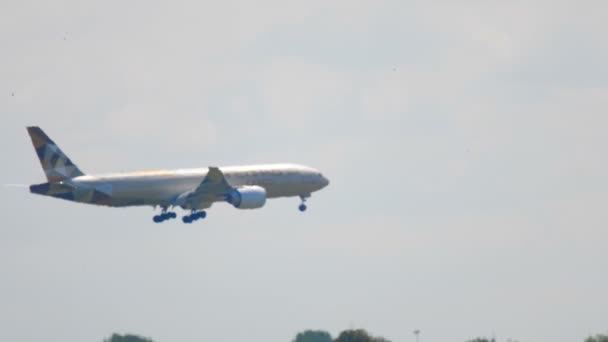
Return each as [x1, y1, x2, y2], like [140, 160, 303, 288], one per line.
[27, 126, 329, 224]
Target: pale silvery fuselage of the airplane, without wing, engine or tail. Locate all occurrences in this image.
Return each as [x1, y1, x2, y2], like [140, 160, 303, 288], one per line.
[69, 164, 329, 207]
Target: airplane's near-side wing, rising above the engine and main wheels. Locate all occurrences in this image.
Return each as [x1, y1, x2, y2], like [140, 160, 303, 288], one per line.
[178, 166, 232, 209]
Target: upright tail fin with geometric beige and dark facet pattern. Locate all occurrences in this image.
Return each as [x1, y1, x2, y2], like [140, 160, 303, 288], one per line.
[27, 126, 83, 183]
